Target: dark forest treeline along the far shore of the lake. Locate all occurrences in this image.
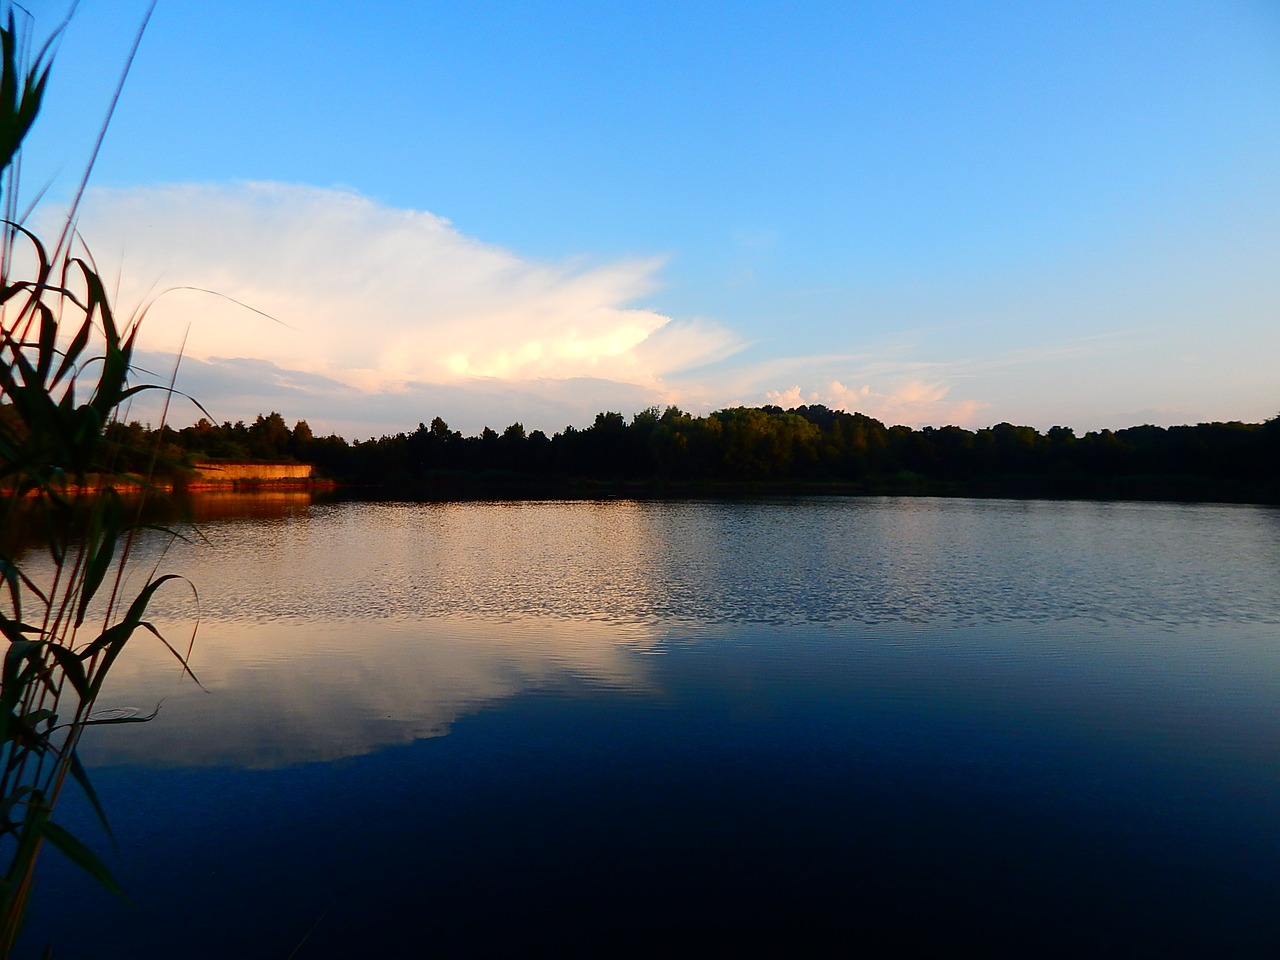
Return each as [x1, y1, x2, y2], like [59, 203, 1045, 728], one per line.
[92, 404, 1280, 503]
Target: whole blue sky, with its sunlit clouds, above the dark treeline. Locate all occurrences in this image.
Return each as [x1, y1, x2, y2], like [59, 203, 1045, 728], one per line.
[12, 0, 1280, 436]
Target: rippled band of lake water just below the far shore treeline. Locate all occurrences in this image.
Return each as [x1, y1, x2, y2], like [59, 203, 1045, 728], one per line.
[127, 498, 1280, 625]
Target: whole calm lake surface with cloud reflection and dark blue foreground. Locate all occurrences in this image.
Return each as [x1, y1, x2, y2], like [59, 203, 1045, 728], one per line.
[17, 495, 1280, 960]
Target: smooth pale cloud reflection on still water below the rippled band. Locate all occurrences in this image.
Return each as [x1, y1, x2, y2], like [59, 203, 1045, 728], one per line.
[83, 617, 652, 769]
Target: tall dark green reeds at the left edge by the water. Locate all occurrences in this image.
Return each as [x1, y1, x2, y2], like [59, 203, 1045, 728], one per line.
[0, 8, 191, 957]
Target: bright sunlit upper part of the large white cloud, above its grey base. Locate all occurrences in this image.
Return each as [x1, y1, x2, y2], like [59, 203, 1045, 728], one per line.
[49, 183, 739, 393]
